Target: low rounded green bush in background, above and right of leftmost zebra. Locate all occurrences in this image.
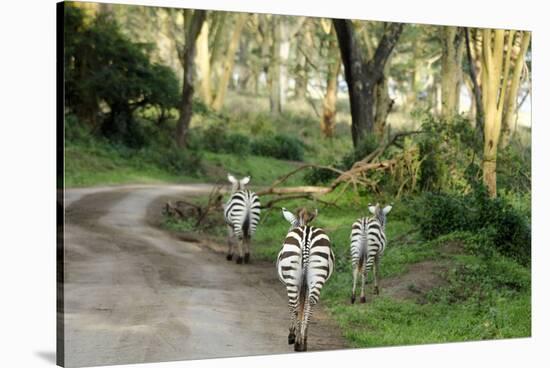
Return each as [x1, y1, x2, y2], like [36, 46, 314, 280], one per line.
[252, 134, 304, 161]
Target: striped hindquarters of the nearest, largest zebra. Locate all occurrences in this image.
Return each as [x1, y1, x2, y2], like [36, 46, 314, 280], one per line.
[277, 226, 334, 305]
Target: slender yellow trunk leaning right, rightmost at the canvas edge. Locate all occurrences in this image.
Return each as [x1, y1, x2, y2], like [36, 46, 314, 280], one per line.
[501, 32, 531, 148]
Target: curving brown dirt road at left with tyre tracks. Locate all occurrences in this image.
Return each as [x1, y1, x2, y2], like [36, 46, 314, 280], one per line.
[61, 185, 344, 367]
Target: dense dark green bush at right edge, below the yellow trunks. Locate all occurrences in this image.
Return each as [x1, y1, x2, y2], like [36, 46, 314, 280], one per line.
[411, 187, 531, 264]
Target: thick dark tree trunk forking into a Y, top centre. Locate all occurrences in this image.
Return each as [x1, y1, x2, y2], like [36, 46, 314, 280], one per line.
[332, 19, 403, 147]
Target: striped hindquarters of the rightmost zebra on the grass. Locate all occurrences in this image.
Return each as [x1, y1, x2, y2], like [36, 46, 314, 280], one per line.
[350, 217, 386, 270]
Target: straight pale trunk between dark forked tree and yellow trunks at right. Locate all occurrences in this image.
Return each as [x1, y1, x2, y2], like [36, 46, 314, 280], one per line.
[441, 27, 465, 119]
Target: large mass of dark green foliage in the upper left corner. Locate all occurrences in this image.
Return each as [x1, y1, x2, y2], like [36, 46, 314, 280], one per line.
[64, 5, 179, 148]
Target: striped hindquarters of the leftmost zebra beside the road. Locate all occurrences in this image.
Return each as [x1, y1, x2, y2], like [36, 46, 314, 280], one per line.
[224, 190, 260, 239]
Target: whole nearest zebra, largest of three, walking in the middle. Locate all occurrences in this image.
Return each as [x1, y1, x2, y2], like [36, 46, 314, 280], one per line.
[277, 208, 334, 351]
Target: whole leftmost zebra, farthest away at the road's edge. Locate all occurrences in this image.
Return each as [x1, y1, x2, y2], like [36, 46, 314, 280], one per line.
[223, 174, 260, 264]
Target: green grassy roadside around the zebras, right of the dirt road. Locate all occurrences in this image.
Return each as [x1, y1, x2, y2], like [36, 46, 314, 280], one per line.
[165, 191, 531, 347]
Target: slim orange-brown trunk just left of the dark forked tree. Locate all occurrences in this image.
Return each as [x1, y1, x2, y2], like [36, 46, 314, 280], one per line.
[321, 30, 342, 138]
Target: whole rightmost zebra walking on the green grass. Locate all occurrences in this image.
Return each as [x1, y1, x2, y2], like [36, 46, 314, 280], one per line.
[351, 203, 392, 304]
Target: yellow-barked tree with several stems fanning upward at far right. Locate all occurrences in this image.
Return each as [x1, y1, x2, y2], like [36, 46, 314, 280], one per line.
[476, 29, 531, 197]
